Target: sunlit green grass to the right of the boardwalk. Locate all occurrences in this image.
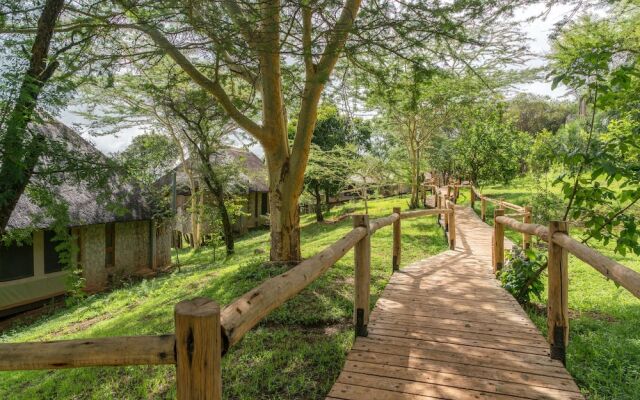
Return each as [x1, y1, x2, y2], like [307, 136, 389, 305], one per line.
[465, 178, 640, 399]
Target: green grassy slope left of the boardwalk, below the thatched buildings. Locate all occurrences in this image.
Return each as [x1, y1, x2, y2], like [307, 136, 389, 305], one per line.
[0, 198, 446, 399]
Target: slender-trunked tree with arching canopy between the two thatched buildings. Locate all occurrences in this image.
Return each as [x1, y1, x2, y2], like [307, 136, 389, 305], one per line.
[82, 65, 240, 254]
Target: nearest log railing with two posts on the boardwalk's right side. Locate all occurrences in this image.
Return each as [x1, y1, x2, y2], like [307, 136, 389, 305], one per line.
[492, 212, 640, 363]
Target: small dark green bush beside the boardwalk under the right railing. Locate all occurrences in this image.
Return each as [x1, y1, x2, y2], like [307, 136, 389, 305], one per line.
[497, 246, 547, 304]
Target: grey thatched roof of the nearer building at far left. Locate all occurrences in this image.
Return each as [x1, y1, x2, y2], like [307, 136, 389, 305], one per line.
[7, 120, 148, 229]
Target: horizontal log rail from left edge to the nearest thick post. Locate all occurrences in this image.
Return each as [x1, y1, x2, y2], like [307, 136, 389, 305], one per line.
[0, 335, 176, 371]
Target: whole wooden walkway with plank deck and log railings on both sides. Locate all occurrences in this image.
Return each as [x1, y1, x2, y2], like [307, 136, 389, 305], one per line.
[5, 186, 640, 400]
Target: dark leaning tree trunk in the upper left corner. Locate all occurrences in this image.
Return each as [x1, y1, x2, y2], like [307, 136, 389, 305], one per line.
[0, 0, 64, 235]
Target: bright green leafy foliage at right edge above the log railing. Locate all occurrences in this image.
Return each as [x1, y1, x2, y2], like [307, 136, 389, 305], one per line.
[551, 9, 640, 254]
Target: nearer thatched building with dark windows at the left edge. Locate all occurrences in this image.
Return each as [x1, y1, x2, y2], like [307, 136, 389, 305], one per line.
[0, 121, 171, 316]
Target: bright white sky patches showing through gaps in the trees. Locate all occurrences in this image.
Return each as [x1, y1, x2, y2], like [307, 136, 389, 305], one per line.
[60, 5, 571, 154]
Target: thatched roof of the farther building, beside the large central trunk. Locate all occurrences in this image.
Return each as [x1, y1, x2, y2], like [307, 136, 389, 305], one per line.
[156, 148, 269, 196]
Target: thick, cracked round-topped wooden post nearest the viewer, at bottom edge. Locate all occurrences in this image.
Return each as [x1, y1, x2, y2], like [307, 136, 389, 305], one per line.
[174, 297, 222, 400]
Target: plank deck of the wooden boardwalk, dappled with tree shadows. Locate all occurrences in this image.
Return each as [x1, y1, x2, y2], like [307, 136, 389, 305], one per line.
[327, 207, 583, 400]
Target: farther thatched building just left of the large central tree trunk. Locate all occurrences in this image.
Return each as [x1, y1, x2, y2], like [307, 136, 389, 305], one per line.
[157, 148, 269, 244]
